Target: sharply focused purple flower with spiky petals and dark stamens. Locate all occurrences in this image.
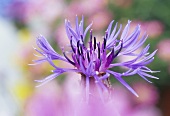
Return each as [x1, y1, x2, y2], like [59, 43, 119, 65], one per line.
[32, 16, 158, 98]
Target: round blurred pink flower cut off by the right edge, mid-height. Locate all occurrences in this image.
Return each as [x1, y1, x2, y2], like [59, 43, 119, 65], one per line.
[157, 39, 170, 61]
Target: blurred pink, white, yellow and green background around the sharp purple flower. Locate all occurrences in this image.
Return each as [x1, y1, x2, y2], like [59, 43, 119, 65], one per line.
[0, 0, 170, 116]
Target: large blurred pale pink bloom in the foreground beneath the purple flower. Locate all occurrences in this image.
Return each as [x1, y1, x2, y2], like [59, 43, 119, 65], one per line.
[25, 73, 161, 116]
